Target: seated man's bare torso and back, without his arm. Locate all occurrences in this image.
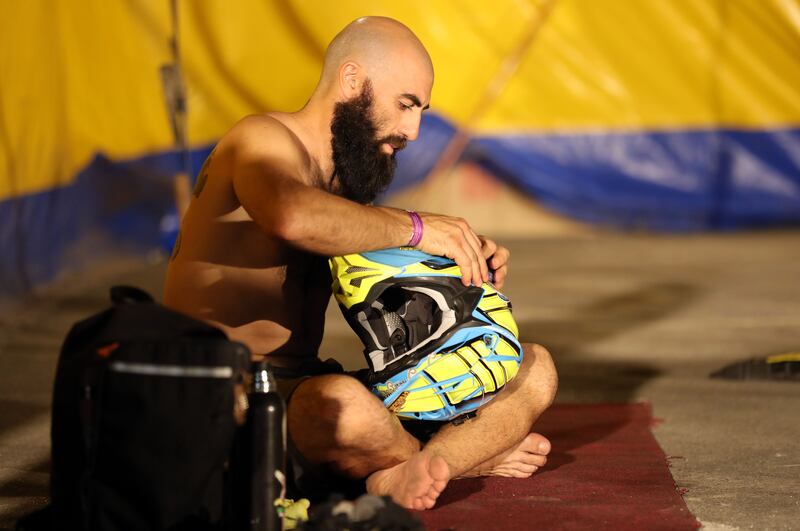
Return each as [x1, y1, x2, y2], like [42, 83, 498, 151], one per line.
[164, 113, 330, 366]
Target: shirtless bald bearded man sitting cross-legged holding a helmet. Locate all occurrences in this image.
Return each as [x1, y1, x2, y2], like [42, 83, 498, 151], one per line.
[164, 17, 556, 509]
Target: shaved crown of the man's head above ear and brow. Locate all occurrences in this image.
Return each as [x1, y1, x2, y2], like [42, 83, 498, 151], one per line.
[320, 17, 433, 93]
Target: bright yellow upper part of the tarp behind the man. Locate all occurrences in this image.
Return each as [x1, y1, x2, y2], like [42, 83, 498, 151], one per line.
[0, 0, 800, 199]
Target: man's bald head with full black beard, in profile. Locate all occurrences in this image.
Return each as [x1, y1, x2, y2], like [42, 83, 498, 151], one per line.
[310, 17, 433, 198]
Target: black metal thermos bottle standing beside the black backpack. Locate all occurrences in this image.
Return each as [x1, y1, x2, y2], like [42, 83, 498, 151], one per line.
[247, 361, 286, 531]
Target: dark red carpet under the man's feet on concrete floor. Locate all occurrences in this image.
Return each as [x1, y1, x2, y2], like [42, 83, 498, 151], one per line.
[417, 404, 700, 531]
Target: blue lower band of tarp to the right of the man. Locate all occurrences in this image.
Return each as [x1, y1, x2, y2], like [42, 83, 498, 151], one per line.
[472, 128, 800, 231]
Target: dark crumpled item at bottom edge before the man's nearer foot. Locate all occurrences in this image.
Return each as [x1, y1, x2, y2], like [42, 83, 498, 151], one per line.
[297, 494, 425, 531]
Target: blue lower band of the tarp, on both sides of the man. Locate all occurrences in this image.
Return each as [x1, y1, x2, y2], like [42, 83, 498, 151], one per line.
[0, 115, 800, 300]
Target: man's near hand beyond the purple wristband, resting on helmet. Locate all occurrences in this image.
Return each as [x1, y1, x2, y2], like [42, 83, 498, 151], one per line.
[418, 212, 490, 286]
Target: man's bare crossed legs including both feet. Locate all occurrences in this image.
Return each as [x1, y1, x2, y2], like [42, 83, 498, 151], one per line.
[288, 344, 558, 509]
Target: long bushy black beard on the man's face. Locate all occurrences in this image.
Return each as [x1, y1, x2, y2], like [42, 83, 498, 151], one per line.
[331, 80, 406, 204]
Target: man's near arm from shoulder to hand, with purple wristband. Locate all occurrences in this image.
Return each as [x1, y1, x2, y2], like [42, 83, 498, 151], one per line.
[233, 119, 488, 285]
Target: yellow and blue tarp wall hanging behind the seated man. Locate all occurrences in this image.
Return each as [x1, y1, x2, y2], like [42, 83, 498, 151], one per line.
[0, 0, 800, 291]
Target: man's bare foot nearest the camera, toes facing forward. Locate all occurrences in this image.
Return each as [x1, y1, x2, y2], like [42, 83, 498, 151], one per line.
[367, 451, 450, 511]
